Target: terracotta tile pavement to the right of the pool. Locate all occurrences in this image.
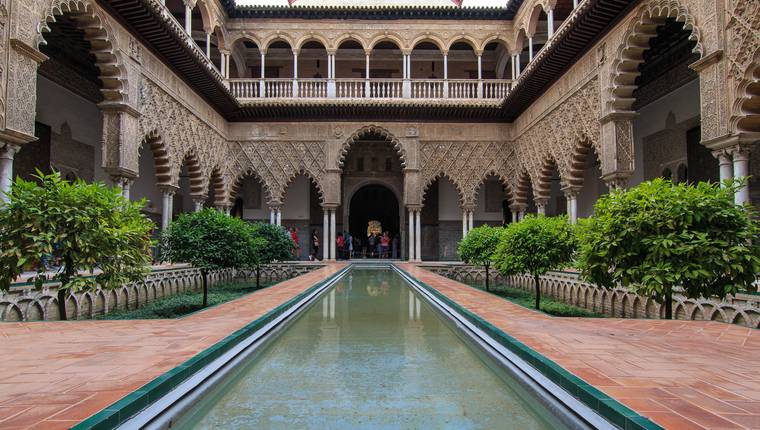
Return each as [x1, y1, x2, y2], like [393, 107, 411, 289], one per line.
[400, 264, 760, 429]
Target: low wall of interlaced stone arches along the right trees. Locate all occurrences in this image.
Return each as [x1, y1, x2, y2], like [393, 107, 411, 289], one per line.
[424, 263, 760, 328]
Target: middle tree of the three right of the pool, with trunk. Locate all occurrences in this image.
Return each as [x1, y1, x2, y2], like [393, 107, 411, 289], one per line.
[493, 216, 575, 309]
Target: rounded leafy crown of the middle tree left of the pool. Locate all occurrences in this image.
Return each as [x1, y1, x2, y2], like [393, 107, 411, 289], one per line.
[164, 209, 252, 272]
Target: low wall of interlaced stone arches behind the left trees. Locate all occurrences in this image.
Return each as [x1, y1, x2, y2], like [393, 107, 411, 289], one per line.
[0, 262, 322, 322]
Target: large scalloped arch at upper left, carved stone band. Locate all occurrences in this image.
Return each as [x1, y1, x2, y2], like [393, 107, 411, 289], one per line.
[36, 0, 129, 103]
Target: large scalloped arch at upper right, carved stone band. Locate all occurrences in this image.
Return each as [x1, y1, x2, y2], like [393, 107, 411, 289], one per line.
[608, 0, 704, 111]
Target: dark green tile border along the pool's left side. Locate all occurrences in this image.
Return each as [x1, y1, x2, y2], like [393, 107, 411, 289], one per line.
[71, 264, 351, 430]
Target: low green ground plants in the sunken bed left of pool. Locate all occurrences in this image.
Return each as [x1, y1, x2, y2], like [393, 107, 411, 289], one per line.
[99, 282, 268, 320]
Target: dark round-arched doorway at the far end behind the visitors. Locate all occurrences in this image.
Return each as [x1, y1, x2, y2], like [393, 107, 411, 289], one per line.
[348, 184, 401, 258]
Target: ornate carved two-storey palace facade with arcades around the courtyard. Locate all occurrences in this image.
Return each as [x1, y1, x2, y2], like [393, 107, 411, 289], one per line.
[0, 0, 760, 260]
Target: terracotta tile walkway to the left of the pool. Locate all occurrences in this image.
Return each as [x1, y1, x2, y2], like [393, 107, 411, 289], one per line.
[0, 264, 343, 430]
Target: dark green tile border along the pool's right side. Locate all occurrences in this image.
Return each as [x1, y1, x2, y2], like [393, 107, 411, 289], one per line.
[394, 265, 663, 430]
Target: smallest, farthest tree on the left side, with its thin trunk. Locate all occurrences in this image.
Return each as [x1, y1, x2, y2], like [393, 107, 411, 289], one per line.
[245, 222, 294, 286]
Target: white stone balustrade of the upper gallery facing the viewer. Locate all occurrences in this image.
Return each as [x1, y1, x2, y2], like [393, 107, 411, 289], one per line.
[227, 78, 512, 101]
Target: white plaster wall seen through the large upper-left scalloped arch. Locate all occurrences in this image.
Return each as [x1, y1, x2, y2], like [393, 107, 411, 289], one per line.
[35, 75, 112, 185]
